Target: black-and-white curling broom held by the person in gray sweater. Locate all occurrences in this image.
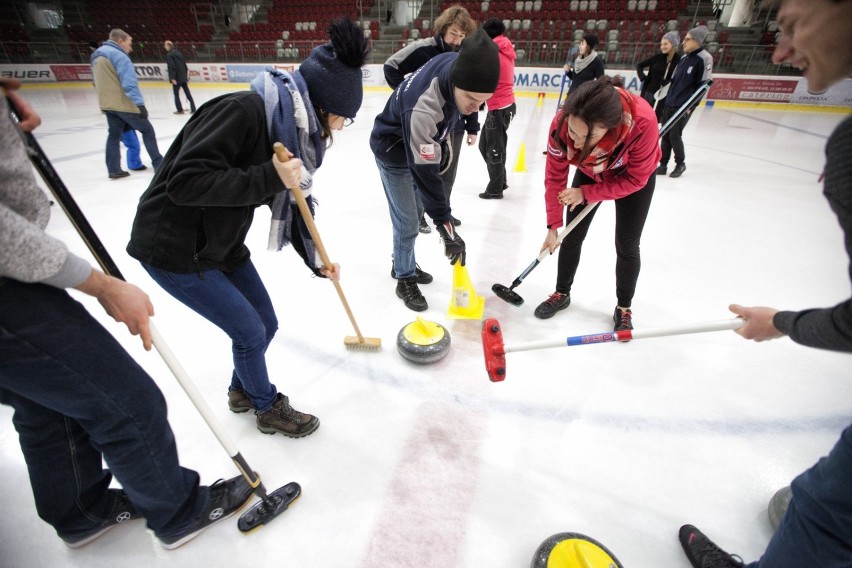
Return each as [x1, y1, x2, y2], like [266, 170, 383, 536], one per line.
[9, 103, 302, 533]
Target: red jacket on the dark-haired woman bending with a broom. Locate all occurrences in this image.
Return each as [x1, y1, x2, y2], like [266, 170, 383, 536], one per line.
[544, 94, 662, 229]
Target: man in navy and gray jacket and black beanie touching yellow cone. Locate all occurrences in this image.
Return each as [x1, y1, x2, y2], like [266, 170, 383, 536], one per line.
[370, 30, 500, 312]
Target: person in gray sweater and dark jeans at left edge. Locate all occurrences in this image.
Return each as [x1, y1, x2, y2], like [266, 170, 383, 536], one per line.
[0, 78, 252, 549]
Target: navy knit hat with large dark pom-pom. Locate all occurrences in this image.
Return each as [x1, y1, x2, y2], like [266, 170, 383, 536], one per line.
[297, 18, 369, 118]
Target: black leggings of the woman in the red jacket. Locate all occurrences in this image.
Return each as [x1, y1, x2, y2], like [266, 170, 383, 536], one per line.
[556, 170, 656, 308]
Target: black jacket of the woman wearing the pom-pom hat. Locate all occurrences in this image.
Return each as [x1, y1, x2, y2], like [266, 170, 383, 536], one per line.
[127, 91, 286, 274]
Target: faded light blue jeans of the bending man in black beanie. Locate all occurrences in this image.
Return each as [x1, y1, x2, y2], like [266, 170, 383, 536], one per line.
[376, 156, 423, 278]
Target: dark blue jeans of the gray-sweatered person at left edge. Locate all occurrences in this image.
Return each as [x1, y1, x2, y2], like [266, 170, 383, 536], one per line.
[0, 279, 208, 538]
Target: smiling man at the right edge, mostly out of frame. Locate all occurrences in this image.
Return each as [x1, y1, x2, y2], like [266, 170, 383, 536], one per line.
[678, 0, 852, 568]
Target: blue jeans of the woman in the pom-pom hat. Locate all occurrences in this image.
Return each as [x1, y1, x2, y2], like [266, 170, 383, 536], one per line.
[142, 260, 278, 412]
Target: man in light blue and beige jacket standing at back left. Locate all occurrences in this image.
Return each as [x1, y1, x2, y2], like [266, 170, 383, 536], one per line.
[91, 28, 163, 179]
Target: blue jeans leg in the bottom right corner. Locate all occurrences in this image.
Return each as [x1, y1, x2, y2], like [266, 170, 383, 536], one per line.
[747, 425, 852, 568]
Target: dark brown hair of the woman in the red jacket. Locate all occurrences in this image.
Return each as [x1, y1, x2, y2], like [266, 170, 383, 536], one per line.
[552, 75, 624, 160]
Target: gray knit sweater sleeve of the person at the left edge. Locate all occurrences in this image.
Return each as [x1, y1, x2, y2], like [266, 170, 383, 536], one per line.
[0, 96, 92, 288]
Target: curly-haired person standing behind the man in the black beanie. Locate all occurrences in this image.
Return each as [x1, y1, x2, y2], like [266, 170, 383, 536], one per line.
[384, 4, 479, 233]
